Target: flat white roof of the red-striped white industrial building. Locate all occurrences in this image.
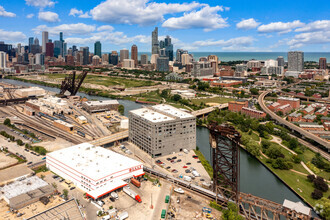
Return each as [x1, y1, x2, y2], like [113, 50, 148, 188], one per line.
[46, 143, 142, 181]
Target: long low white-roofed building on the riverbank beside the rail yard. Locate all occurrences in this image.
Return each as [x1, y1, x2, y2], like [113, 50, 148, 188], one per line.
[82, 100, 119, 113]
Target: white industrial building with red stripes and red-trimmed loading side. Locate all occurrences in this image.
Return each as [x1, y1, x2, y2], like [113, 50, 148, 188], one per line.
[46, 143, 144, 199]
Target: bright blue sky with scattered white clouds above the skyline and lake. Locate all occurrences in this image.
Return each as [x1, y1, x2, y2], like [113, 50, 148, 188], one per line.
[0, 0, 330, 52]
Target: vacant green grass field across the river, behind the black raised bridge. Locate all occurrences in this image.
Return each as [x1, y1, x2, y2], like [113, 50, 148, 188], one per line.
[45, 74, 159, 88]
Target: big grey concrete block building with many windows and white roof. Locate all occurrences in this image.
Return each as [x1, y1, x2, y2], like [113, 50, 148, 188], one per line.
[129, 104, 196, 157]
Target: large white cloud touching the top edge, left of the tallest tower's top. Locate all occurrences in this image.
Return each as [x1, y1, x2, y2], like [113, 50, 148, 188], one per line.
[90, 0, 202, 25]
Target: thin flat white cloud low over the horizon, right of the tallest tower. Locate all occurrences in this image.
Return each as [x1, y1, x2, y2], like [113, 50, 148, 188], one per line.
[193, 36, 255, 47]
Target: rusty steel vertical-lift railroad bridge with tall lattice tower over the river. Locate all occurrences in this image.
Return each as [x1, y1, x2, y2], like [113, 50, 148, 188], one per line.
[209, 123, 317, 220]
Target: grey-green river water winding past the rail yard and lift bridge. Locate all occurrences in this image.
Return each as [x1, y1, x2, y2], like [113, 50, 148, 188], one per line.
[0, 79, 314, 211]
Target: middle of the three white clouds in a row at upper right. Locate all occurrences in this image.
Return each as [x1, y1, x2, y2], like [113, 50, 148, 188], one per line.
[258, 20, 305, 34]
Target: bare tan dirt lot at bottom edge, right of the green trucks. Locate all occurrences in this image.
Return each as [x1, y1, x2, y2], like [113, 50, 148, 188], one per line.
[169, 190, 221, 220]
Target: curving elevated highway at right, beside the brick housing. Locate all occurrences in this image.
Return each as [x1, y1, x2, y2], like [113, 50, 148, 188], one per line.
[258, 91, 330, 155]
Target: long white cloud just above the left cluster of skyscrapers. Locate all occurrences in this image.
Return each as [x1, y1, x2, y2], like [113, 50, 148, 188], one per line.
[33, 23, 96, 35]
